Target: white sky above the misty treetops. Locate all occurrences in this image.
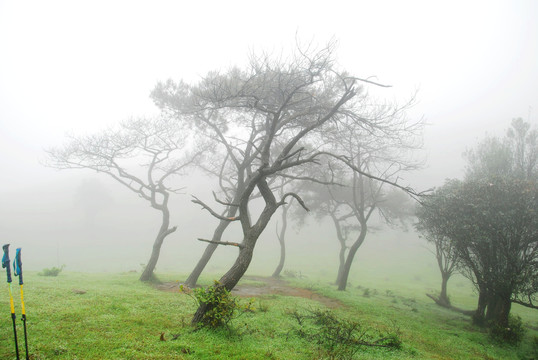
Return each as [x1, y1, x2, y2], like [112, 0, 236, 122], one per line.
[0, 0, 538, 193]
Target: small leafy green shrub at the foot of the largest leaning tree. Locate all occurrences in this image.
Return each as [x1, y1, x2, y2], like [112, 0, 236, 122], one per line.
[179, 280, 253, 329]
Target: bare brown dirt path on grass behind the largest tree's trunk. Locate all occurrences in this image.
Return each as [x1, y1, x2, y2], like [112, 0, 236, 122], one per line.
[156, 276, 344, 309]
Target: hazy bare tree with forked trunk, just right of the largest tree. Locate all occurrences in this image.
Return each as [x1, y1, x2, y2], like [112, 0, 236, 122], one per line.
[318, 115, 422, 290]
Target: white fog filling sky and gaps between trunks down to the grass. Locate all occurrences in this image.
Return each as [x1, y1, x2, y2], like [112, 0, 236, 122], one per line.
[0, 0, 538, 275]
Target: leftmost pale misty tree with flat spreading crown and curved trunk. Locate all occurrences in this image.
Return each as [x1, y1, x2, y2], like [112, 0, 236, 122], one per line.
[45, 117, 201, 281]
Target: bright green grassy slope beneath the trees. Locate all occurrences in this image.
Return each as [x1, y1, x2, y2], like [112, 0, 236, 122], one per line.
[0, 272, 537, 359]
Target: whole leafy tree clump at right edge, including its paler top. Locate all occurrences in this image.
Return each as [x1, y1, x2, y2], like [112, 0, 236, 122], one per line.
[417, 119, 538, 328]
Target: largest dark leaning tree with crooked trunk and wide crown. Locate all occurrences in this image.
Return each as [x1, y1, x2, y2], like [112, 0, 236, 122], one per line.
[153, 46, 418, 323]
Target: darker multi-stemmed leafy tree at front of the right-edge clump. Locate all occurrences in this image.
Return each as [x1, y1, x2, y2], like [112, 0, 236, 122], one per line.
[450, 178, 538, 327]
